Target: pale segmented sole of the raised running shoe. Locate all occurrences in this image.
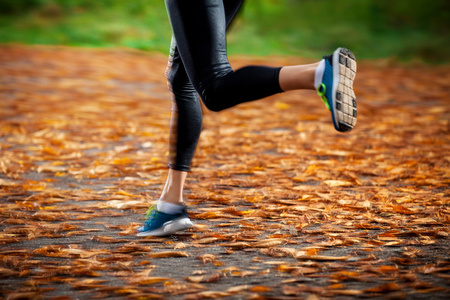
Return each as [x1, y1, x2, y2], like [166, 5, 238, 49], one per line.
[331, 48, 358, 131]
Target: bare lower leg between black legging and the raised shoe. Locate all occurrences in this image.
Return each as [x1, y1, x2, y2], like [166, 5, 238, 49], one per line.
[279, 62, 319, 92]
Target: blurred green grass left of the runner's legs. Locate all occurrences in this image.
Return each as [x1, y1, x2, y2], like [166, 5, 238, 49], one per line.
[0, 1, 171, 51]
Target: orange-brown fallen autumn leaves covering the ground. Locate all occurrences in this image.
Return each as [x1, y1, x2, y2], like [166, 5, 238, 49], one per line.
[0, 46, 450, 299]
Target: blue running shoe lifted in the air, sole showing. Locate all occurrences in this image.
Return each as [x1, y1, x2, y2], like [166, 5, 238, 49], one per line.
[317, 48, 357, 132]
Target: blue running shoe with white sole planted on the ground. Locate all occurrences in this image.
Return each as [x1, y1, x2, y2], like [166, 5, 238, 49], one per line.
[137, 205, 193, 236]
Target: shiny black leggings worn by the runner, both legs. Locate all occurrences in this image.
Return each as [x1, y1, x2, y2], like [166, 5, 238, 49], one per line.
[166, 0, 282, 171]
